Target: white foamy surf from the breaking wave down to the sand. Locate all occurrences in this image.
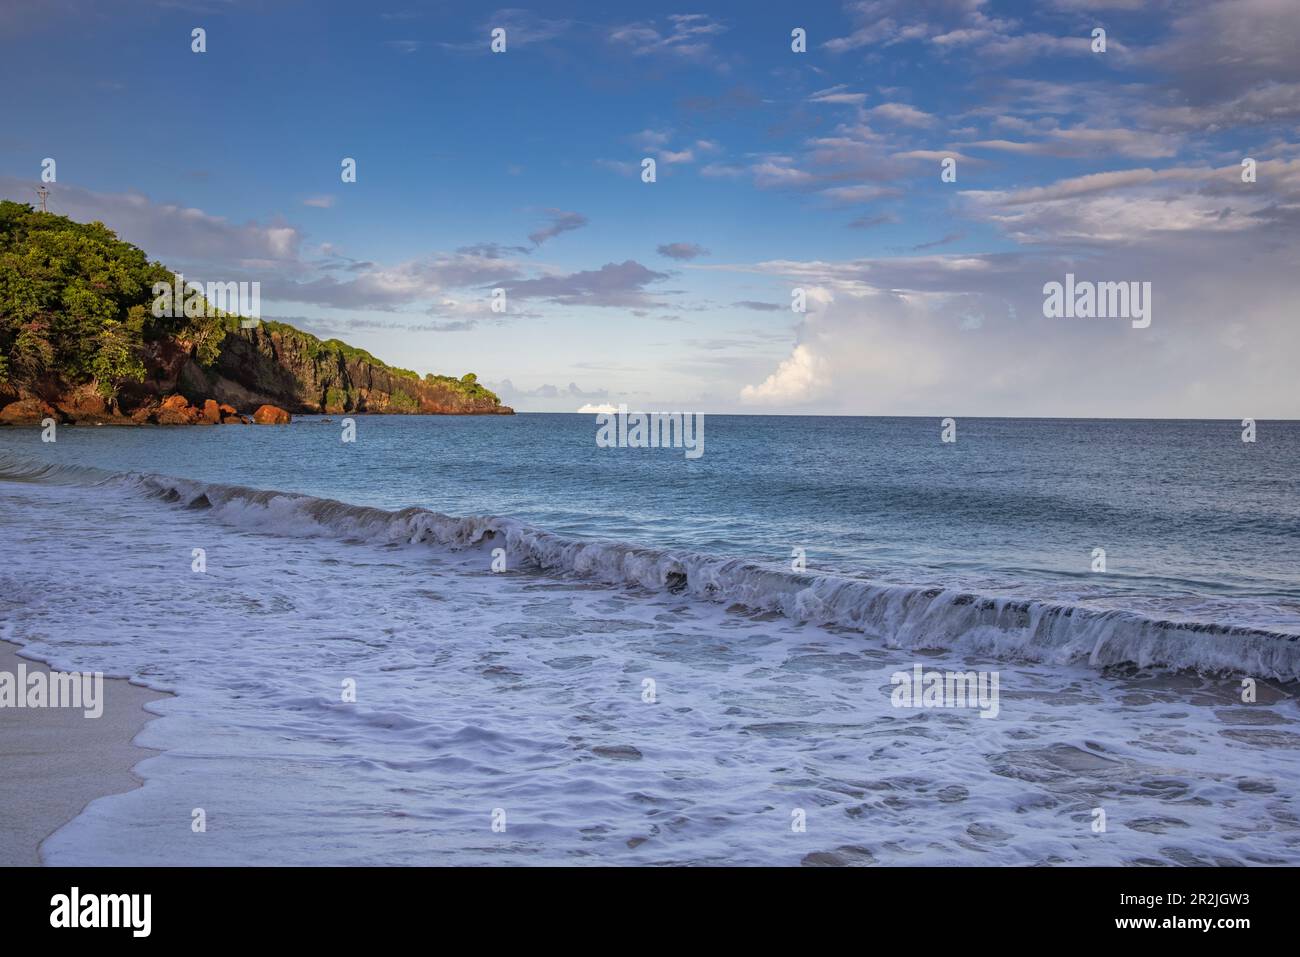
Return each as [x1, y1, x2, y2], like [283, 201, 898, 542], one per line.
[0, 455, 1300, 865]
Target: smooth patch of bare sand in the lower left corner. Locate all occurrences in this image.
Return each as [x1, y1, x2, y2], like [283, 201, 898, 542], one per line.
[0, 641, 170, 867]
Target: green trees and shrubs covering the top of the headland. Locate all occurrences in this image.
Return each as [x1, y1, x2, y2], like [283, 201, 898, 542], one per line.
[0, 200, 497, 411]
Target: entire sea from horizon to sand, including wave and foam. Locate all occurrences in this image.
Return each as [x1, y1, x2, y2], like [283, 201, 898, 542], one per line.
[0, 415, 1300, 865]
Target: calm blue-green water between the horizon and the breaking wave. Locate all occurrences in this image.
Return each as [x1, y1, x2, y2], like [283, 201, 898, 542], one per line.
[0, 413, 1300, 632]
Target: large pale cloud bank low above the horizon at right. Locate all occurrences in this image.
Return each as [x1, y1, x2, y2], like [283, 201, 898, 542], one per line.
[738, 224, 1300, 419]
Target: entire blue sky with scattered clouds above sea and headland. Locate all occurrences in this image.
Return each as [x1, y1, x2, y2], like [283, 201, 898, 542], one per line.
[0, 0, 1300, 419]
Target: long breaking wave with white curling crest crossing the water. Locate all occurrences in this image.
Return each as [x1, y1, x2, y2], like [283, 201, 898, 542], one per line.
[0, 456, 1300, 681]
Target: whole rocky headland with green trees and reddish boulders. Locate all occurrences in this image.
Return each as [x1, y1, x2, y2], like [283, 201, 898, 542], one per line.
[0, 200, 514, 424]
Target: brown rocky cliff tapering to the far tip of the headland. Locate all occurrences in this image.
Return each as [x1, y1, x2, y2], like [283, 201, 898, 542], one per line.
[177, 322, 514, 415]
